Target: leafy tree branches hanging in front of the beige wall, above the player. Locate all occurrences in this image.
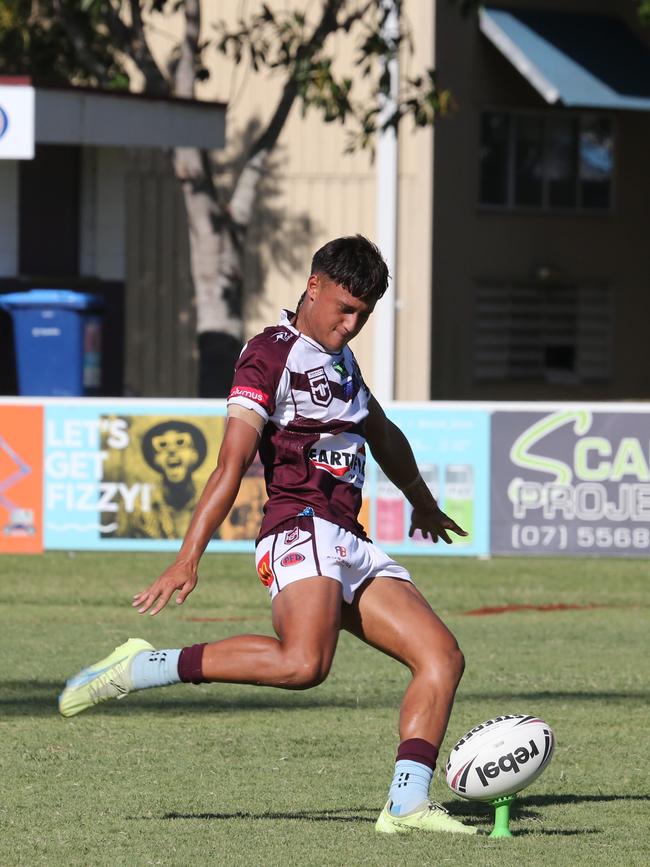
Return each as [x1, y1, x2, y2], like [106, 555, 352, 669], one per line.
[216, 0, 451, 151]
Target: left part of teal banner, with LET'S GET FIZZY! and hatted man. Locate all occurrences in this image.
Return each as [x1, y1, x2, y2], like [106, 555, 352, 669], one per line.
[45, 402, 265, 550]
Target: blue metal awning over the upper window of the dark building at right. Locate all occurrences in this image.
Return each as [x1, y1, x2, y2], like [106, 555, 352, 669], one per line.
[479, 6, 650, 111]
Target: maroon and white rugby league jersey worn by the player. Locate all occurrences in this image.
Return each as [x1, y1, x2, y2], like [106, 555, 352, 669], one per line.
[228, 310, 370, 539]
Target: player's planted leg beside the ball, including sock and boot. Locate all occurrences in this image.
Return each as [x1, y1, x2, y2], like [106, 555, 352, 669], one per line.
[342, 577, 477, 834]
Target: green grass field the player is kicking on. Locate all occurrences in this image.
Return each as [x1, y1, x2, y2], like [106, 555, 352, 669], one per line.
[0, 553, 650, 867]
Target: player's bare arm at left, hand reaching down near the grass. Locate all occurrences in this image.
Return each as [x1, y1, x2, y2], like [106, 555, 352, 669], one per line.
[132, 418, 259, 615]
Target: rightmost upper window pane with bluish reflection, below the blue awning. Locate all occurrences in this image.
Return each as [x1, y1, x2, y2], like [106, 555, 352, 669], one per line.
[580, 118, 614, 208]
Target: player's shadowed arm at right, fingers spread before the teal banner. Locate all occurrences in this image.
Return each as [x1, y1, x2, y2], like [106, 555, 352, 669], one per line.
[366, 397, 468, 545]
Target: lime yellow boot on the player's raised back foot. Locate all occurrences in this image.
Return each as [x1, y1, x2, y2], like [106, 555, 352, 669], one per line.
[59, 638, 154, 716]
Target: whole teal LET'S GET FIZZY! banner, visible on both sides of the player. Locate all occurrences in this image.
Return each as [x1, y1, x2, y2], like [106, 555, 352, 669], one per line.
[38, 400, 489, 555]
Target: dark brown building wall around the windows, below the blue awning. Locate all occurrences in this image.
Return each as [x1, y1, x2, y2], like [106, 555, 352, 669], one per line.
[432, 0, 650, 400]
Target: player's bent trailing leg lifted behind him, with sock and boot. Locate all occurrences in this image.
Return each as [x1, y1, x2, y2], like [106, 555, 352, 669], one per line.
[59, 576, 341, 717]
